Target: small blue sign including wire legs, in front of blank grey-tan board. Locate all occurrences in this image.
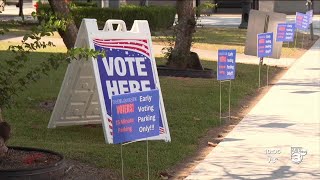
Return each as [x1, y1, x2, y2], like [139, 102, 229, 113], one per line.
[257, 32, 273, 88]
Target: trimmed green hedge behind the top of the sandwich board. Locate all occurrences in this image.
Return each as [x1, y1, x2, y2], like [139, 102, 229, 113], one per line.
[38, 4, 176, 31]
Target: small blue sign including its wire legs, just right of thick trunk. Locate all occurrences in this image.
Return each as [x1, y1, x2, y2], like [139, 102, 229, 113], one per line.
[217, 50, 236, 124]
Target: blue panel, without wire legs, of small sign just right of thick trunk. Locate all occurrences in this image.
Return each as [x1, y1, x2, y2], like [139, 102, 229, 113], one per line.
[217, 50, 236, 81]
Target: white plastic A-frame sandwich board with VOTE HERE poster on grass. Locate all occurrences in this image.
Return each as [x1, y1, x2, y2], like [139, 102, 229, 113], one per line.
[48, 19, 171, 144]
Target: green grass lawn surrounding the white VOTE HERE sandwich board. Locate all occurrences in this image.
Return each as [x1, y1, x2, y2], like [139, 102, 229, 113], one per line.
[0, 47, 279, 179]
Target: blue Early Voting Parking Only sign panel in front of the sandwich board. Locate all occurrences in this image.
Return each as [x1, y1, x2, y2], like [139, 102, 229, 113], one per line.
[112, 90, 160, 144]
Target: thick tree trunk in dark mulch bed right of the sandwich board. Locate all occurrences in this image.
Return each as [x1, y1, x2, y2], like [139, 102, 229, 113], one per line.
[167, 0, 203, 69]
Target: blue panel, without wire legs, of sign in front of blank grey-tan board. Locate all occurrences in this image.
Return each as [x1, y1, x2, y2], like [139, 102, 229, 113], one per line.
[257, 33, 273, 57]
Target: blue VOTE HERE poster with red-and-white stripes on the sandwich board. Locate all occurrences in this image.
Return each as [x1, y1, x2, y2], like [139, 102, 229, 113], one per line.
[93, 38, 166, 141]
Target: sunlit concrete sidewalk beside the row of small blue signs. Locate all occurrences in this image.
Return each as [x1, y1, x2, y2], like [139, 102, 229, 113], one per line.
[187, 40, 320, 180]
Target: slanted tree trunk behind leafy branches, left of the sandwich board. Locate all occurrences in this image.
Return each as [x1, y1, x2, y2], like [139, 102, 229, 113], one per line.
[49, 0, 78, 49]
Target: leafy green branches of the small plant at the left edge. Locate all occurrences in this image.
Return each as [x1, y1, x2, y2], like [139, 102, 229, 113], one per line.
[0, 7, 105, 155]
